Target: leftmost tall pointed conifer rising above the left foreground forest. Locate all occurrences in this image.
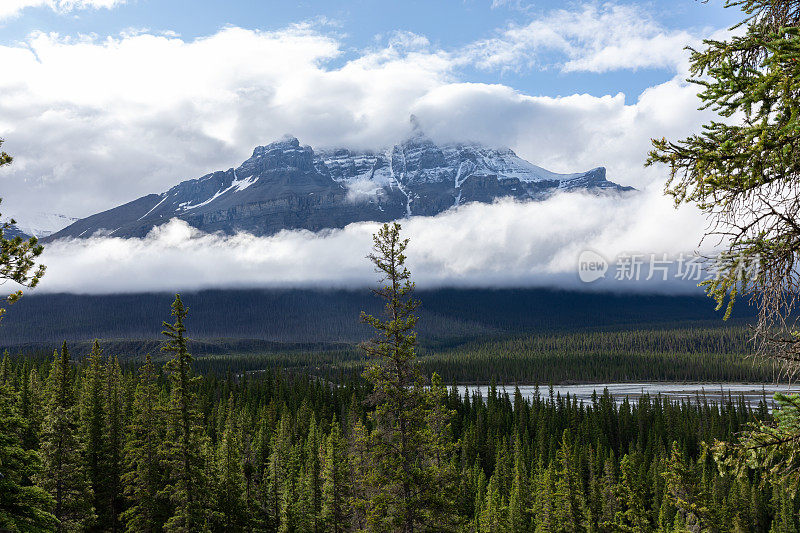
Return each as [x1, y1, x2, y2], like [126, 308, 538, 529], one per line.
[37, 342, 95, 533]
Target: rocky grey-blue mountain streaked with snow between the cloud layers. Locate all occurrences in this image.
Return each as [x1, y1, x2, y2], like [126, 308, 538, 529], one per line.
[49, 134, 632, 240]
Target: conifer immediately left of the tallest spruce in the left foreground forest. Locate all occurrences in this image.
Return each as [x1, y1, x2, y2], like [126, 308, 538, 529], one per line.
[120, 354, 170, 533]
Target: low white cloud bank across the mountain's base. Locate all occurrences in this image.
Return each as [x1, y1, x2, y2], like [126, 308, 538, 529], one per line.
[26, 191, 705, 294]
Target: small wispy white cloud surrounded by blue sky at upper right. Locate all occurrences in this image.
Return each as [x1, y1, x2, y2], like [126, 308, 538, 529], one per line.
[464, 3, 701, 73]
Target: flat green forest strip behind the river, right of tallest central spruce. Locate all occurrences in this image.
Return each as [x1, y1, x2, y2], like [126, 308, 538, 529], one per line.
[421, 327, 776, 384]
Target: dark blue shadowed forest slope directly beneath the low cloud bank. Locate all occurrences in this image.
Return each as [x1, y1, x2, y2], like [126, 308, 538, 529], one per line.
[0, 289, 752, 344]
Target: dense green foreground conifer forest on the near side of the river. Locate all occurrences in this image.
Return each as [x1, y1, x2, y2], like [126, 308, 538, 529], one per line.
[0, 225, 800, 532]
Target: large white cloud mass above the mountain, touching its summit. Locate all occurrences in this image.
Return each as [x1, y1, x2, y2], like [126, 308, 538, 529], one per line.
[0, 12, 707, 218]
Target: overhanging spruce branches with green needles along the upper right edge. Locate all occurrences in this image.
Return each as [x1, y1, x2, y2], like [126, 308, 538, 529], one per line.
[647, 0, 800, 375]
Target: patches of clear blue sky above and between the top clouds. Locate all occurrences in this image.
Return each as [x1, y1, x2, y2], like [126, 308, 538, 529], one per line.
[0, 0, 739, 96]
